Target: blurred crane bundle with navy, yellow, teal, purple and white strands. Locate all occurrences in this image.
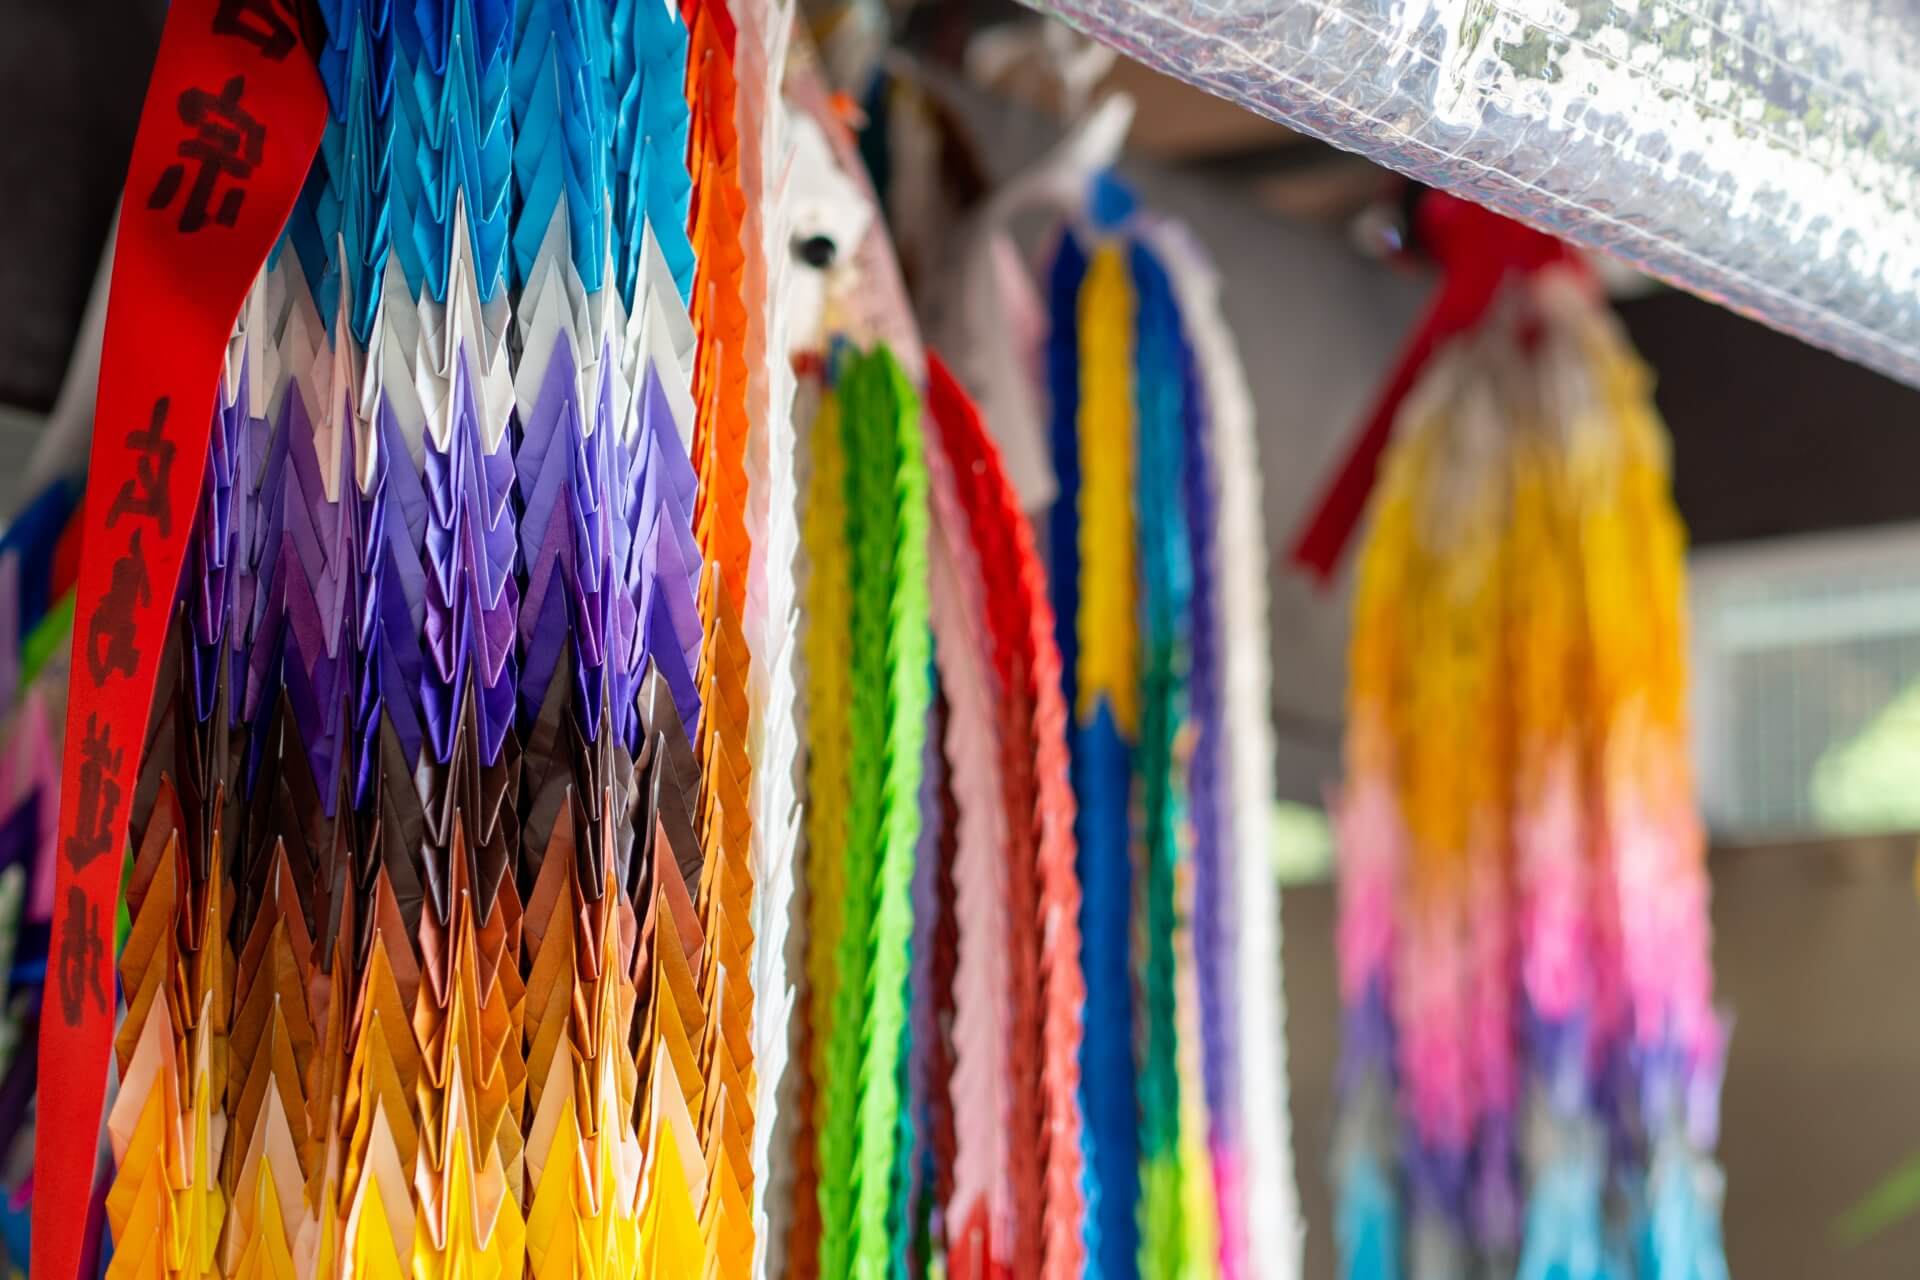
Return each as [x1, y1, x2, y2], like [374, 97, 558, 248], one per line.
[1046, 178, 1300, 1276]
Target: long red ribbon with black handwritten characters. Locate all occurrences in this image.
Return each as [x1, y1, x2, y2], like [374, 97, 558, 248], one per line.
[33, 0, 326, 1280]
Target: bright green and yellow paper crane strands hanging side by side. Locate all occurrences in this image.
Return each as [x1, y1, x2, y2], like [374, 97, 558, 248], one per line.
[787, 339, 931, 1276]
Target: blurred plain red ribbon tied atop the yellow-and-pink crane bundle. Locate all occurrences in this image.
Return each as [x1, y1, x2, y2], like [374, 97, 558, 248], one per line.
[1288, 192, 1582, 585]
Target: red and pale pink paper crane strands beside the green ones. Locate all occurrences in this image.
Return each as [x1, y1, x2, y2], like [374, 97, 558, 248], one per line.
[927, 357, 1089, 1276]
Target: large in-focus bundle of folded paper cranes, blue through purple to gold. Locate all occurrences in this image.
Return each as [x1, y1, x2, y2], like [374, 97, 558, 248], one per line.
[95, 0, 771, 1278]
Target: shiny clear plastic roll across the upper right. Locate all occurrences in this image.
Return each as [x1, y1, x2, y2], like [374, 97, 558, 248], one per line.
[1027, 0, 1920, 386]
